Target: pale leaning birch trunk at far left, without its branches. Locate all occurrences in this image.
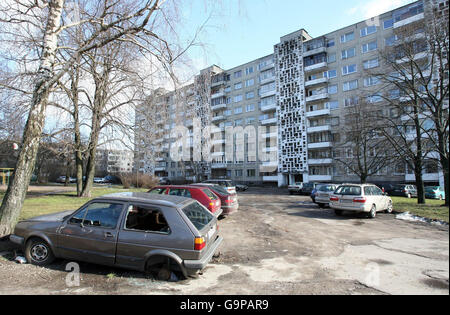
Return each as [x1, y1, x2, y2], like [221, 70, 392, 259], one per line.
[0, 0, 64, 237]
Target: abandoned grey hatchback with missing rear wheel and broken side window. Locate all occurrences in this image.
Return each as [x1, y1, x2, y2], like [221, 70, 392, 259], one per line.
[10, 193, 223, 279]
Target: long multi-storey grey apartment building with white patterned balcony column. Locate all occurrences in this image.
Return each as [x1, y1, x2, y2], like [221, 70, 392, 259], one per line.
[135, 0, 448, 186]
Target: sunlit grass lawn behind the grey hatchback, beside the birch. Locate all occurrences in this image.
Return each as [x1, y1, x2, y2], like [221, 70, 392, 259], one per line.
[0, 187, 148, 220]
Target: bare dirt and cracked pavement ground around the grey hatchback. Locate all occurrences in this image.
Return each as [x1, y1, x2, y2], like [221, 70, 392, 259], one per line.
[0, 188, 449, 295]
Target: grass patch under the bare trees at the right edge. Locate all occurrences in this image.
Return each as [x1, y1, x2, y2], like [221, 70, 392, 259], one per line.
[391, 197, 448, 223]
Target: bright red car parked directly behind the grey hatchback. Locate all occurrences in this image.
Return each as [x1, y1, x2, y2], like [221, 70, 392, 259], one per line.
[149, 185, 222, 213]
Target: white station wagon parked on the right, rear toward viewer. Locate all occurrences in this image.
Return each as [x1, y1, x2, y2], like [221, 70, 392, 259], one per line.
[330, 184, 393, 218]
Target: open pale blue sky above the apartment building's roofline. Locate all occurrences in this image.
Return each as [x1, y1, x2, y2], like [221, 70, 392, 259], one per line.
[181, 0, 414, 69]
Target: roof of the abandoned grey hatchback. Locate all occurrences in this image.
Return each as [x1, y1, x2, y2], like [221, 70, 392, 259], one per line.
[99, 192, 193, 207]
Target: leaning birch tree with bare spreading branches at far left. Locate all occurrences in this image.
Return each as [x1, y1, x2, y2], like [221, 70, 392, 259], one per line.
[0, 0, 178, 236]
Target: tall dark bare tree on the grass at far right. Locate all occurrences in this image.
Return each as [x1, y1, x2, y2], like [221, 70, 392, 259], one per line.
[368, 6, 449, 203]
